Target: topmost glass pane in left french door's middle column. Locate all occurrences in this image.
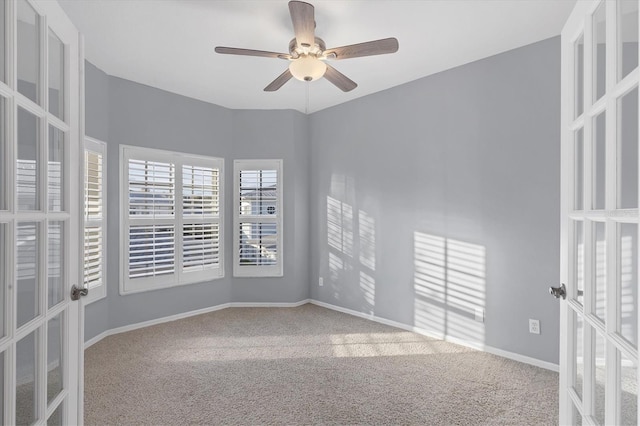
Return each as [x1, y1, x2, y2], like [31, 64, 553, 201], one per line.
[16, 0, 40, 103]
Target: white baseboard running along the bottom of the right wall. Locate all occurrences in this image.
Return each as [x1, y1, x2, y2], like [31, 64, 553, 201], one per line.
[309, 299, 560, 372]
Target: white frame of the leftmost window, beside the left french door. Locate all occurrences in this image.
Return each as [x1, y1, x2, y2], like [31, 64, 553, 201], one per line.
[81, 136, 108, 305]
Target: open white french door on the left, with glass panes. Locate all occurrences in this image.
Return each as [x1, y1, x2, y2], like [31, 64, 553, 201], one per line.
[0, 0, 82, 425]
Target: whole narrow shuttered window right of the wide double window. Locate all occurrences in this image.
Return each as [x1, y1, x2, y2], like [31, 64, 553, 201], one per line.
[233, 160, 282, 277]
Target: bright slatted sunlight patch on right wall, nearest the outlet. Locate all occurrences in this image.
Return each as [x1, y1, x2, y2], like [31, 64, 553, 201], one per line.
[413, 231, 486, 342]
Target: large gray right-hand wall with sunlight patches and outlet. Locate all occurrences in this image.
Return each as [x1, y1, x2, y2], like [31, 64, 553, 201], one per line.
[310, 38, 560, 363]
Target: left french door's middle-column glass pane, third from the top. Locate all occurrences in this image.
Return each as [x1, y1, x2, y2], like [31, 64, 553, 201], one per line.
[16, 222, 40, 327]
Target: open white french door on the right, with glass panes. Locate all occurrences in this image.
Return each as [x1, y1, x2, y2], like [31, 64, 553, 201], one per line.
[560, 0, 639, 425]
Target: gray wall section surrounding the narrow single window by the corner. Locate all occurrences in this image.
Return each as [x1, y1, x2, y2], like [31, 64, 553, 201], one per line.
[231, 110, 309, 302]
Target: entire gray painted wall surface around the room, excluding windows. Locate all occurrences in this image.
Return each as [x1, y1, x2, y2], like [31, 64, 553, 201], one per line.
[85, 38, 560, 363]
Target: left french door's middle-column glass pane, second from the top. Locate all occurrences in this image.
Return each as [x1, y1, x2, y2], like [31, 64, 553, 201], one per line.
[16, 108, 40, 210]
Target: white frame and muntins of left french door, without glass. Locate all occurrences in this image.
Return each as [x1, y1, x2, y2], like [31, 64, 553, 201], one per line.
[9, 0, 84, 424]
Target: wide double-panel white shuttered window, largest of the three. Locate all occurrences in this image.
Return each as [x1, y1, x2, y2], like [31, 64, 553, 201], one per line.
[120, 146, 224, 294]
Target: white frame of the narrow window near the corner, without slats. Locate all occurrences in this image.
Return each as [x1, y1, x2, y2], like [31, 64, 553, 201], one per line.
[233, 159, 284, 278]
